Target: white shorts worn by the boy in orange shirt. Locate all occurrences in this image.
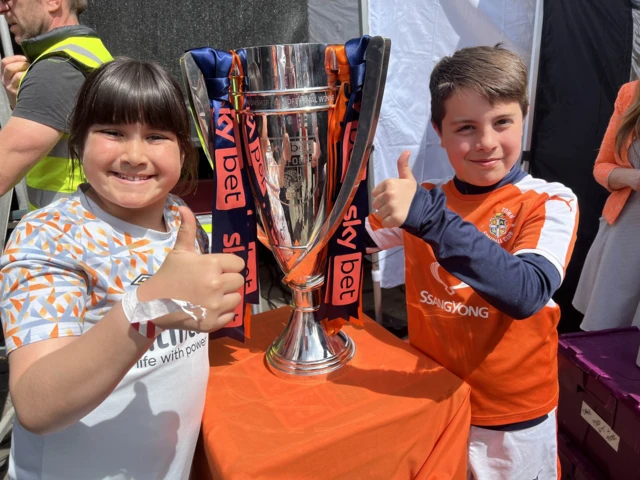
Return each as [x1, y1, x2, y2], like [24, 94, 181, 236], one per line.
[468, 409, 558, 480]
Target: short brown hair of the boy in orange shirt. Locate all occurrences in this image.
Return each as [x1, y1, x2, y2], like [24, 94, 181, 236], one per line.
[429, 43, 529, 130]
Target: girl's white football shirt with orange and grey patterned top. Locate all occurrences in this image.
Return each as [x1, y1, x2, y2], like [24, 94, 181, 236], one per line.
[0, 185, 209, 480]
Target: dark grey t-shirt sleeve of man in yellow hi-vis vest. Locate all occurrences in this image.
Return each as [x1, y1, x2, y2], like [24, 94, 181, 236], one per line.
[12, 57, 85, 133]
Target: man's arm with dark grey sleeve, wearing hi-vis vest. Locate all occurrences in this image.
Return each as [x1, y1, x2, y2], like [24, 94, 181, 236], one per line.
[0, 58, 84, 195]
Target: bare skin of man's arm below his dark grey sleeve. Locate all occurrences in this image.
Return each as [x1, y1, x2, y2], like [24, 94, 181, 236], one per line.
[0, 116, 62, 195]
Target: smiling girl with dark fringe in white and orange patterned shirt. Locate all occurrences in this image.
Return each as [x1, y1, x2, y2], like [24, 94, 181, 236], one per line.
[0, 59, 244, 480]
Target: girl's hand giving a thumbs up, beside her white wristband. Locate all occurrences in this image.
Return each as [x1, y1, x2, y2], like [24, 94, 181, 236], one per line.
[138, 207, 244, 332]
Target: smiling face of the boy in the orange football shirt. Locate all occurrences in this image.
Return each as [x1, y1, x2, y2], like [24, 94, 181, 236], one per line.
[434, 89, 523, 187]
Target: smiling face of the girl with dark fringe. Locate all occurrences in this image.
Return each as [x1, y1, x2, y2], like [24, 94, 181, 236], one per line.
[82, 123, 184, 231]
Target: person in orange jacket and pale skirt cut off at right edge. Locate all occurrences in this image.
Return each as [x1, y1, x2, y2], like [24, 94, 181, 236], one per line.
[573, 81, 640, 330]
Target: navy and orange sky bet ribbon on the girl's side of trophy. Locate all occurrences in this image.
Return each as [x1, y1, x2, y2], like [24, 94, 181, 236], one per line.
[190, 47, 260, 341]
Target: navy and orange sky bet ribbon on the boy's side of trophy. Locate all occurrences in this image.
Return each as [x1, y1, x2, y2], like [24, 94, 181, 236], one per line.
[319, 36, 370, 332]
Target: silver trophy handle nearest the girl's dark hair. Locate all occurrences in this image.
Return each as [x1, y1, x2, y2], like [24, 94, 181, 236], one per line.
[180, 52, 214, 168]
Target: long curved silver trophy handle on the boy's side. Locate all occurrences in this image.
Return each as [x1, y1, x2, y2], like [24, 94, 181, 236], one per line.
[283, 36, 391, 284]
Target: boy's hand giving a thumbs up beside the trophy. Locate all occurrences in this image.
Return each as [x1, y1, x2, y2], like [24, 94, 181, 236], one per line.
[371, 150, 418, 228]
